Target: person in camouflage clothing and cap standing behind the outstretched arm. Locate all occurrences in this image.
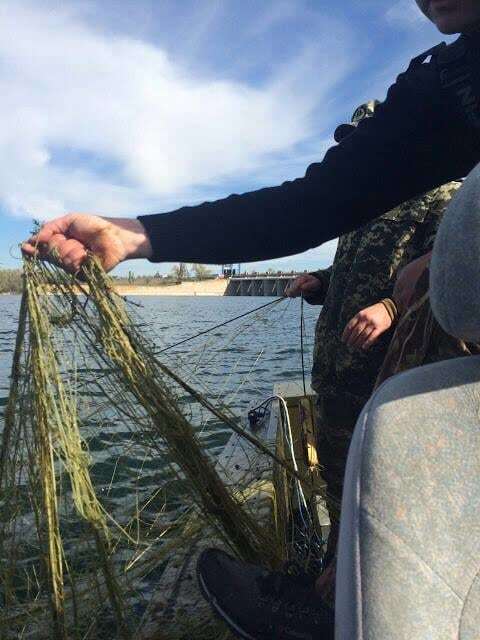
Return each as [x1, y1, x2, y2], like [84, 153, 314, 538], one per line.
[286, 100, 461, 607]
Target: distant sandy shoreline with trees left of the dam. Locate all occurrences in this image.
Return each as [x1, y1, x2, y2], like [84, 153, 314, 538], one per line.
[0, 263, 217, 293]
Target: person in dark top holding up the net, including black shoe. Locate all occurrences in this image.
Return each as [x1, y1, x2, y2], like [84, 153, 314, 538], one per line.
[23, 0, 480, 640]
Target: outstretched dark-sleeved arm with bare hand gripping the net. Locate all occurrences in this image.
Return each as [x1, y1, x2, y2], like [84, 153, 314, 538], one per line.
[21, 56, 472, 269]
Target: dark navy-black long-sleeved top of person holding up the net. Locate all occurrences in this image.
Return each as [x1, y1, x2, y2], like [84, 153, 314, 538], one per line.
[139, 35, 480, 264]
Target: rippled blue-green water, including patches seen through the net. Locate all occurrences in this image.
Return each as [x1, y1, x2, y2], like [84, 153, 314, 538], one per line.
[0, 296, 318, 637]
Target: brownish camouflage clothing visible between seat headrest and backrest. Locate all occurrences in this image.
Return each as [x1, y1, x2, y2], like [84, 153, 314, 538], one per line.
[375, 269, 480, 386]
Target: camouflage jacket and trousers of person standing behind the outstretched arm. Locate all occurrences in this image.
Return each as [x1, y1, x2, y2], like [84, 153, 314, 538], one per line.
[309, 182, 461, 562]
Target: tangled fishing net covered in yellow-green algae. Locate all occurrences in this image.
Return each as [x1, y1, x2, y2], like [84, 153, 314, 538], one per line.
[0, 259, 306, 640]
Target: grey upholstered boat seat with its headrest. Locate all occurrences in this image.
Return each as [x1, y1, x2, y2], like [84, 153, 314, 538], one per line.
[336, 162, 480, 640]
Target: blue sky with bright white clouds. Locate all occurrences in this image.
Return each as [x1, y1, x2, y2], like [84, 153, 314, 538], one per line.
[0, 0, 450, 273]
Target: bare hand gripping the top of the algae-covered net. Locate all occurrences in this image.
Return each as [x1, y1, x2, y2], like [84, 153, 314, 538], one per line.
[22, 213, 152, 273]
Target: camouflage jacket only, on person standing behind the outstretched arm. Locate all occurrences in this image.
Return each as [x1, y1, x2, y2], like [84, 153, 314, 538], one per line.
[312, 182, 460, 404]
